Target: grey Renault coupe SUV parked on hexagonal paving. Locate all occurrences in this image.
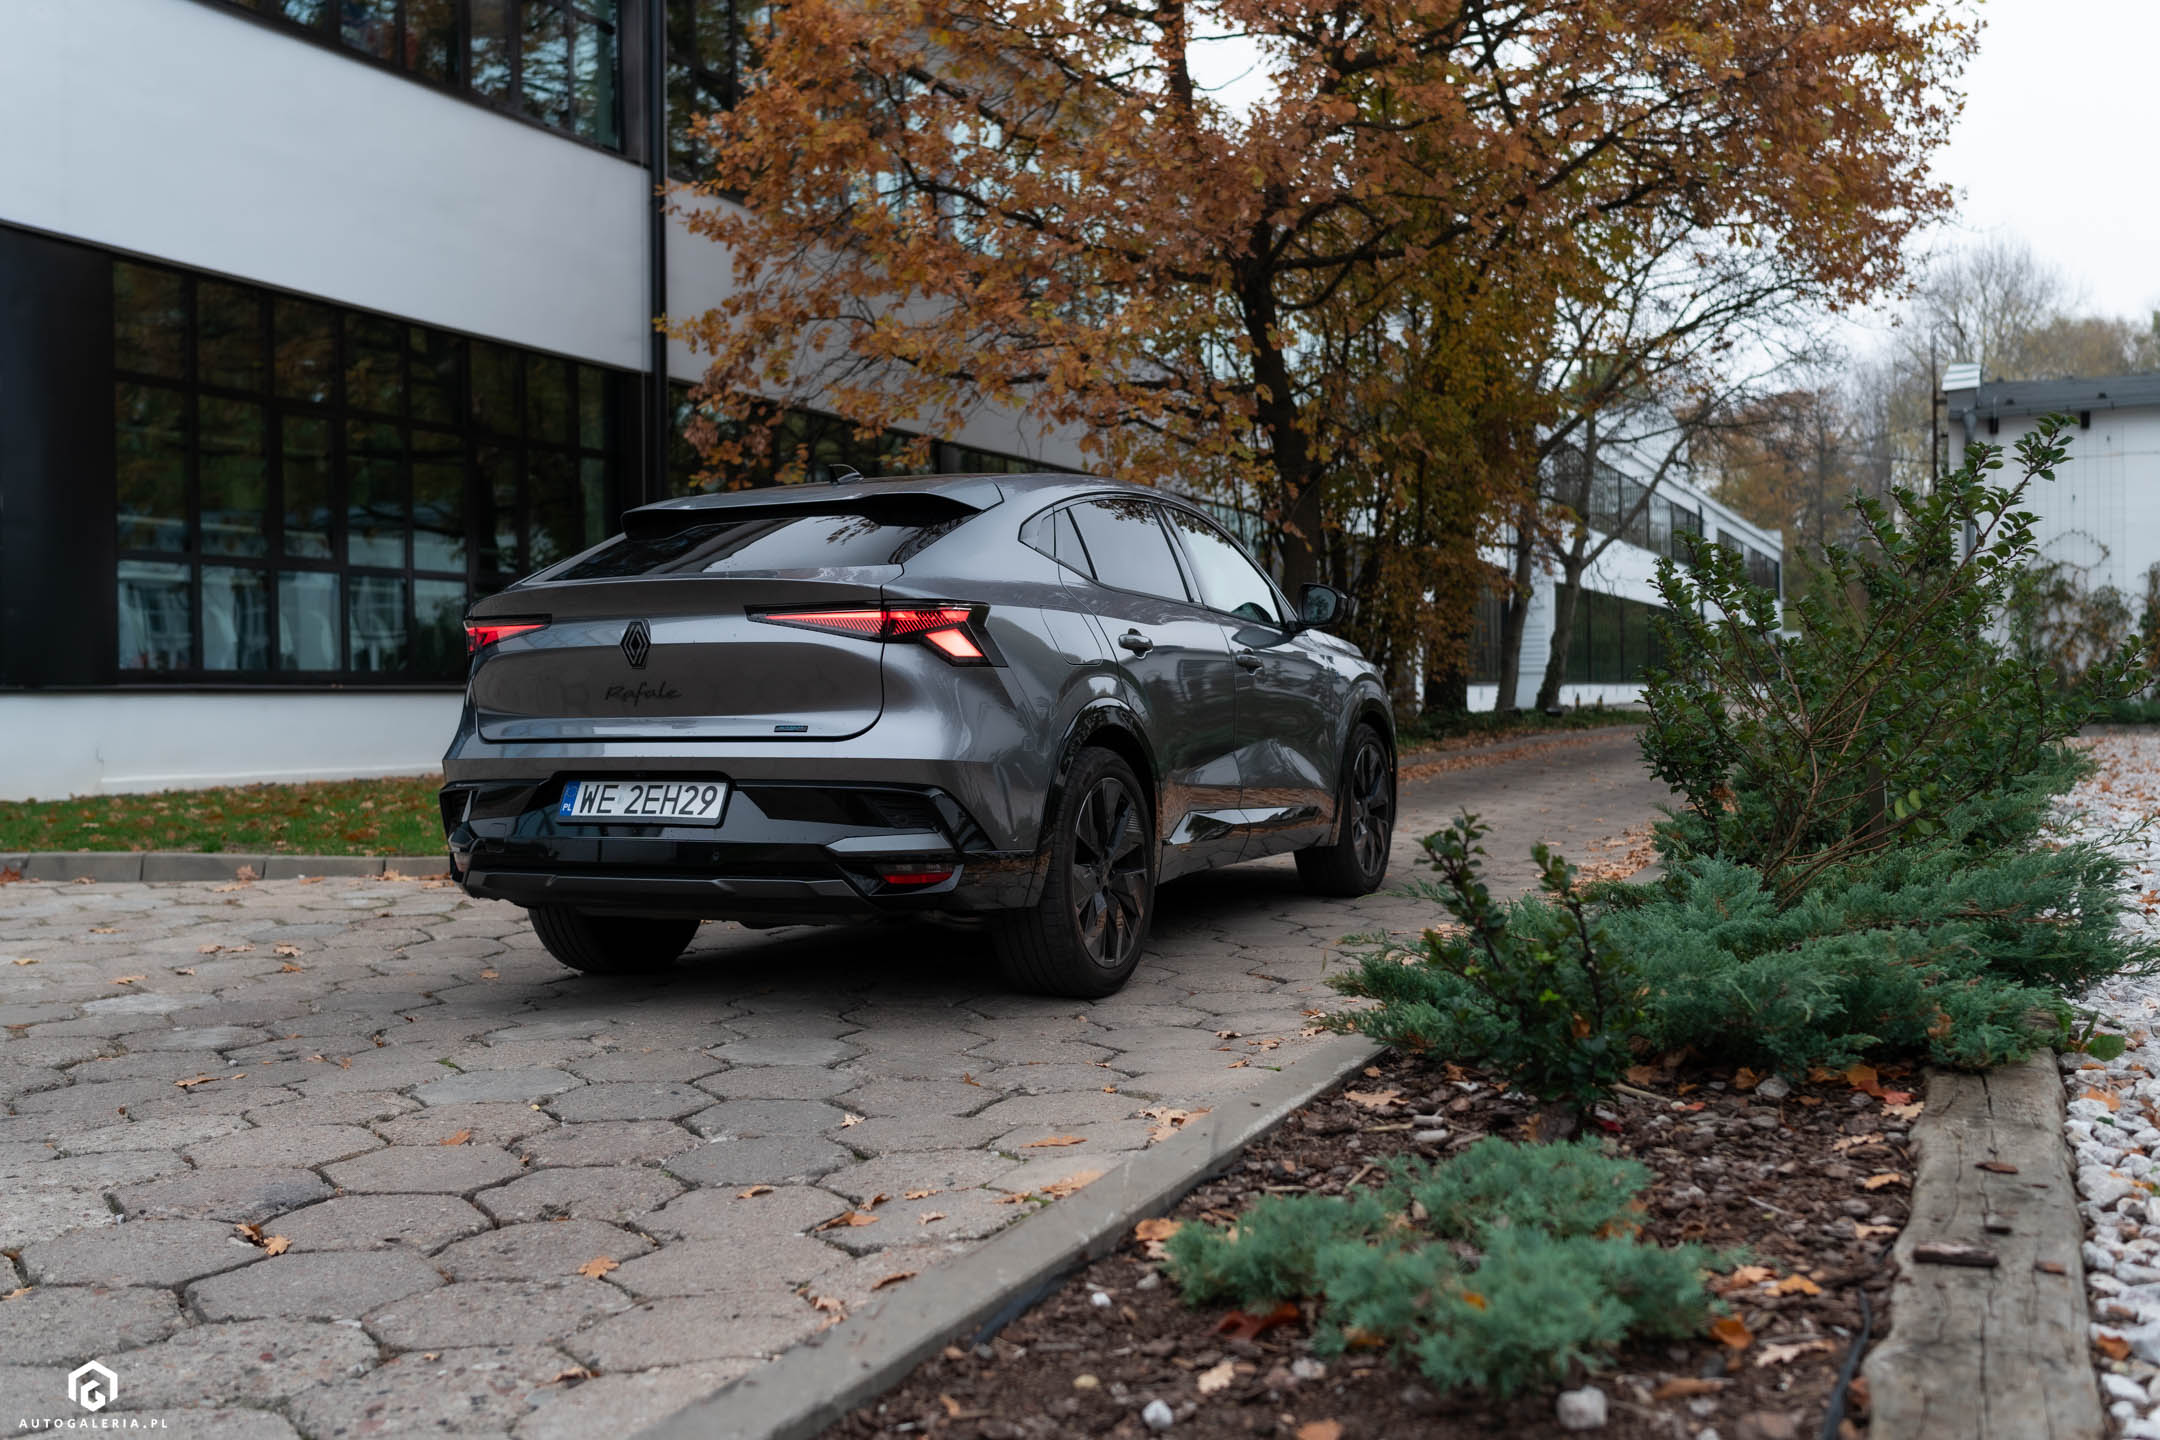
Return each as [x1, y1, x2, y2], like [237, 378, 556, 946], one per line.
[443, 475, 1395, 995]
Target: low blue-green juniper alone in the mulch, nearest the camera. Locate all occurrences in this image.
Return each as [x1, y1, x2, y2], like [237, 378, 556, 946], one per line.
[1166, 1140, 1715, 1395]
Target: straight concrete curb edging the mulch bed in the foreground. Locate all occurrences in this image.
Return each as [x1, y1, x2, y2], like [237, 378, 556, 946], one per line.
[635, 1036, 1380, 1440]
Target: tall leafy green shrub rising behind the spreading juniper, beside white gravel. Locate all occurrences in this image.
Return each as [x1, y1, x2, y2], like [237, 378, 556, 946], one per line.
[1644, 415, 2147, 905]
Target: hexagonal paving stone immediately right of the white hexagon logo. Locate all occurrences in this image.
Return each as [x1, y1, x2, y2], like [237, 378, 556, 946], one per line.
[86, 1319, 376, 1416]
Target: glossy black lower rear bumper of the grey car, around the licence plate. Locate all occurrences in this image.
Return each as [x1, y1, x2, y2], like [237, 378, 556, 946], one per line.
[441, 777, 1041, 922]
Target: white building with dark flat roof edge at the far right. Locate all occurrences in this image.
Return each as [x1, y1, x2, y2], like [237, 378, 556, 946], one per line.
[1942, 363, 2160, 615]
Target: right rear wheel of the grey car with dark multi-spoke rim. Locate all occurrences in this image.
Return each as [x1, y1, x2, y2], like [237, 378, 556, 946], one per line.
[991, 749, 1156, 1000]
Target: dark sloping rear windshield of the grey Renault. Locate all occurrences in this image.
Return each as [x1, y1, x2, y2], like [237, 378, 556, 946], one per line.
[546, 510, 968, 581]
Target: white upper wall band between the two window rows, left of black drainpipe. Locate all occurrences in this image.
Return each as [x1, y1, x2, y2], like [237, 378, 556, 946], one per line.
[0, 0, 650, 369]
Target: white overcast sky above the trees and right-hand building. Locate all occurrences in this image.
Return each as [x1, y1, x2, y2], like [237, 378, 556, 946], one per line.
[1194, 0, 2160, 332]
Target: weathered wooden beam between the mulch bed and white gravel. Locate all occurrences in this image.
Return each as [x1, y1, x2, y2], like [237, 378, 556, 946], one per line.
[1866, 1051, 2108, 1440]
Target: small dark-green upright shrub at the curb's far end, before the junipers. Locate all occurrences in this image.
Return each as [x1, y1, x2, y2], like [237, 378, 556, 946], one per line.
[1335, 814, 1644, 1108]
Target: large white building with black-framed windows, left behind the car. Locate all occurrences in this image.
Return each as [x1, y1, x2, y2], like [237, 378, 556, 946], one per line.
[0, 0, 1080, 799]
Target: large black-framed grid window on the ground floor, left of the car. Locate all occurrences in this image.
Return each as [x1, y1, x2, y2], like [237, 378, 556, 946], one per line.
[112, 255, 622, 680]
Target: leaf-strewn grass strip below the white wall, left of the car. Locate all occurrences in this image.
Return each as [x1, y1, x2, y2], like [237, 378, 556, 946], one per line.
[0, 775, 443, 855]
